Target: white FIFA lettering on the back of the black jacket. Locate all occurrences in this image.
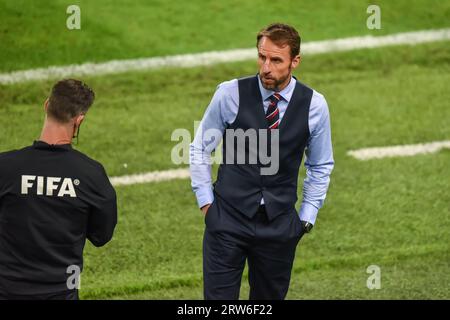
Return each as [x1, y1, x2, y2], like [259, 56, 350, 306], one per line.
[21, 175, 80, 198]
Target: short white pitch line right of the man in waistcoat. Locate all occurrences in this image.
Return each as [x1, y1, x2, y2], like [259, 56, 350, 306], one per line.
[347, 140, 450, 160]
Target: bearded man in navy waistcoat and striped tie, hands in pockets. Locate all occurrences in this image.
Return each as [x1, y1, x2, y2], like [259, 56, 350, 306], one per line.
[190, 23, 334, 300]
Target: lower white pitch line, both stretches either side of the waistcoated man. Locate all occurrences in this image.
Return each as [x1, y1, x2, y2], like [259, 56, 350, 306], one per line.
[110, 140, 450, 186]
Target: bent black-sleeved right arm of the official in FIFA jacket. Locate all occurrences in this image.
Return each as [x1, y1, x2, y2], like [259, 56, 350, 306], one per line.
[87, 173, 117, 247]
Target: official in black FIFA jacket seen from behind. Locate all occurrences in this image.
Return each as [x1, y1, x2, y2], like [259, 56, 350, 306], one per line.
[0, 79, 117, 300]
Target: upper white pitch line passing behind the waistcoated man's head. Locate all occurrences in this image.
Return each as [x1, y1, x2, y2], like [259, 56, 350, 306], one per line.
[0, 29, 450, 84]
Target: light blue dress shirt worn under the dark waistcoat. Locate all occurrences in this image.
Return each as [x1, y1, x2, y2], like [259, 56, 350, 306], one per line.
[190, 77, 334, 224]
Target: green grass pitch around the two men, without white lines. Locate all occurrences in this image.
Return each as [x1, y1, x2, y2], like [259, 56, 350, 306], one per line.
[0, 0, 450, 299]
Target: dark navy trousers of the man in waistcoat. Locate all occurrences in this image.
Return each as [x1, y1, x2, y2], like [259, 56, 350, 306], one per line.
[203, 195, 304, 300]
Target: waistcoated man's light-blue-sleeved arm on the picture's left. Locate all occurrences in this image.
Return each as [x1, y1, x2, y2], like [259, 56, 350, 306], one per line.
[189, 80, 239, 213]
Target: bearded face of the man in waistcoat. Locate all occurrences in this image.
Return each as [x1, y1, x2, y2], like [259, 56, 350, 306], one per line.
[258, 37, 300, 91]
